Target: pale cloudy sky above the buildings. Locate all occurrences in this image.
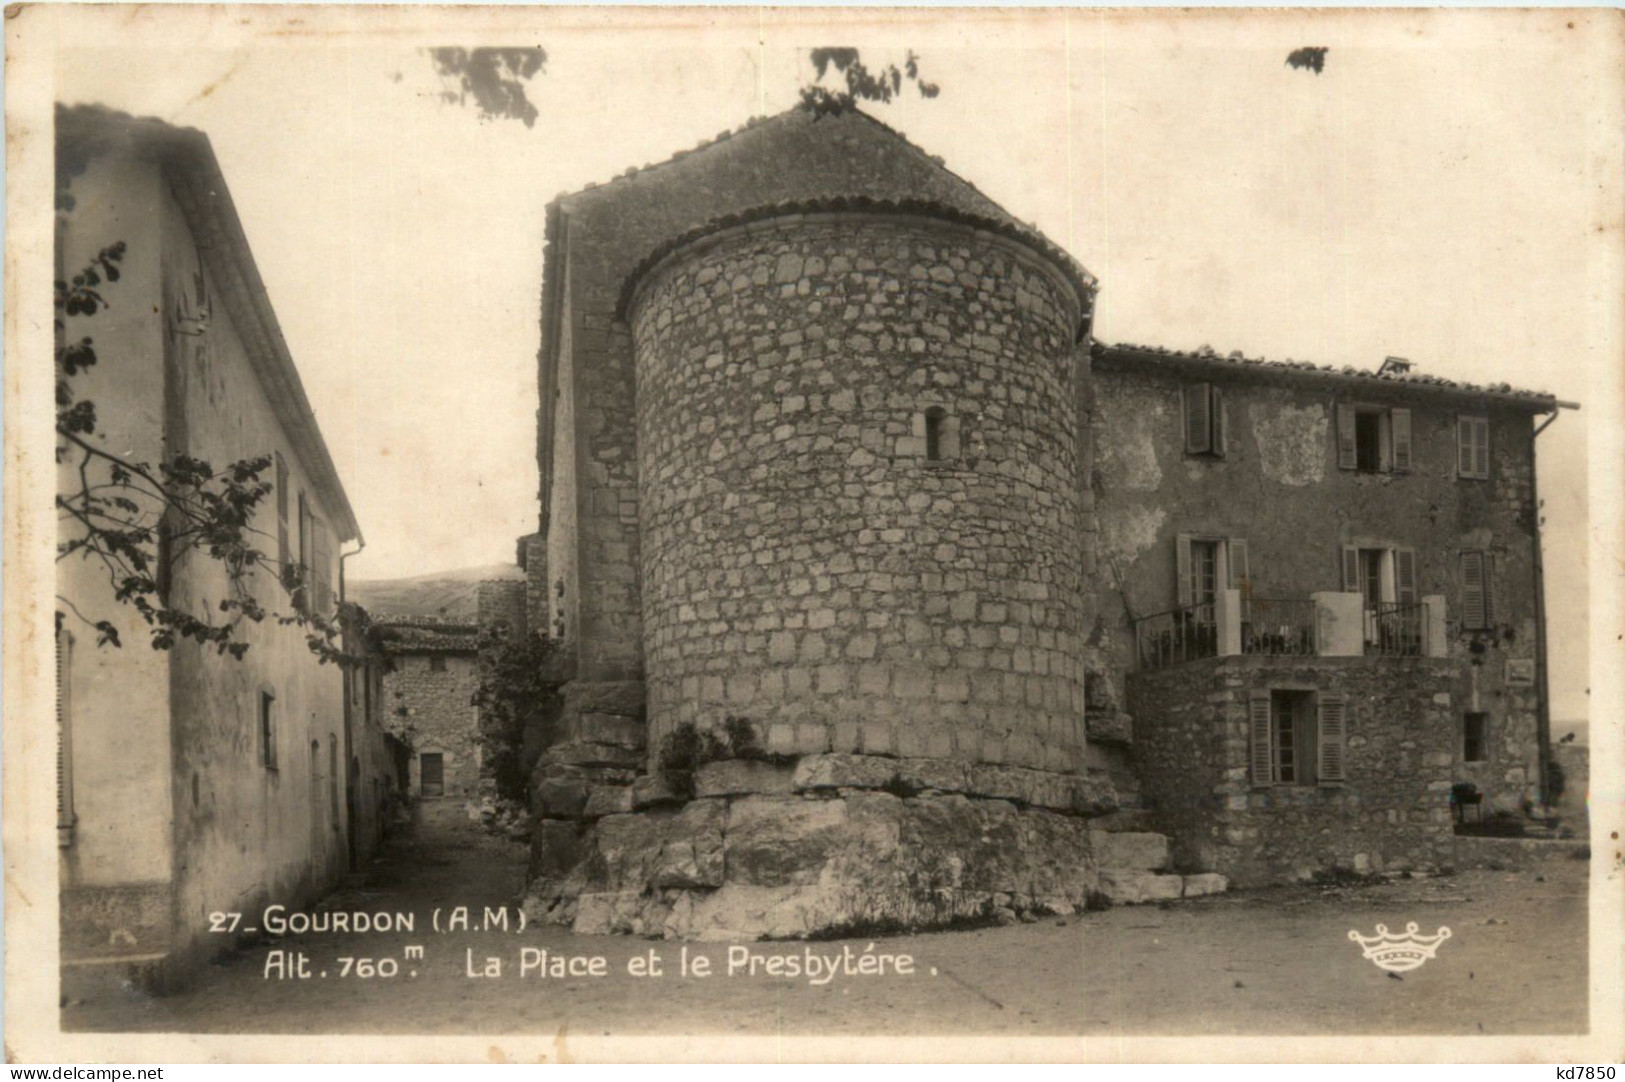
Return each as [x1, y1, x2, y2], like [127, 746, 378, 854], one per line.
[57, 8, 1620, 718]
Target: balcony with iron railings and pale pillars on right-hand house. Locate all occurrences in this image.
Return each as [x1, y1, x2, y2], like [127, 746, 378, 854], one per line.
[1134, 590, 1448, 669]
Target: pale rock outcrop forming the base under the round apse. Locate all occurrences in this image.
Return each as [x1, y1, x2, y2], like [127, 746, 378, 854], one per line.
[525, 788, 1105, 941]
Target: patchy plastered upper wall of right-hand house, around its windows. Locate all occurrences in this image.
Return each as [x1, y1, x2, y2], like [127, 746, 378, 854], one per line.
[1090, 348, 1539, 809]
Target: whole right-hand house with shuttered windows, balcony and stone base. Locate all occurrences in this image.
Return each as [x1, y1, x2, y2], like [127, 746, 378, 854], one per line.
[1094, 346, 1555, 882]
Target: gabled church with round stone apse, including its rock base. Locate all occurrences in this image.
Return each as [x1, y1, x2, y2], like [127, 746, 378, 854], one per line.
[527, 109, 1113, 939]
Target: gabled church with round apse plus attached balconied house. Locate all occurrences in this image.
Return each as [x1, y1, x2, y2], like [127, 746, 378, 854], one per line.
[509, 109, 1555, 937]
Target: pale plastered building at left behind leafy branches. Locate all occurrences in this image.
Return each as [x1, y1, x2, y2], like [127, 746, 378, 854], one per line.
[57, 107, 387, 985]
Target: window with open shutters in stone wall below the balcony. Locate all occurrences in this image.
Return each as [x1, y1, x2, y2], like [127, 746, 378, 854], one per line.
[1248, 689, 1347, 786]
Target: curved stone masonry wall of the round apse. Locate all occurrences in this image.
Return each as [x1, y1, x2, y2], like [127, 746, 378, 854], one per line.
[632, 213, 1084, 772]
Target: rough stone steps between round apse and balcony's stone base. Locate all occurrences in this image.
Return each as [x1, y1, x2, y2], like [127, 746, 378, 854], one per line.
[1089, 711, 1230, 905]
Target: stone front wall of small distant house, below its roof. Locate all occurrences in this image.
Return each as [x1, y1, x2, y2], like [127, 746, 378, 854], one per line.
[384, 653, 479, 798]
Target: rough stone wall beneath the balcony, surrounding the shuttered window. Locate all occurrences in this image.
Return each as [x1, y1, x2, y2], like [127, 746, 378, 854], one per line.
[1128, 656, 1467, 885]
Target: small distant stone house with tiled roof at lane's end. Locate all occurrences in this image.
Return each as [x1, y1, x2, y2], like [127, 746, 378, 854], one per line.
[374, 616, 481, 799]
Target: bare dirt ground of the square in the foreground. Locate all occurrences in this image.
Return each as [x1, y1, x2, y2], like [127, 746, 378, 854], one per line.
[63, 801, 1586, 1038]
